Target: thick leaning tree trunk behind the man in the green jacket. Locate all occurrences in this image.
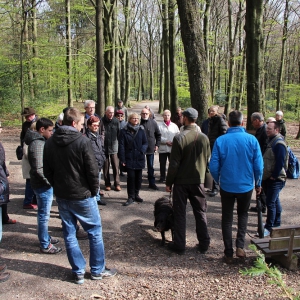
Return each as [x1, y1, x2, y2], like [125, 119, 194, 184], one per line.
[177, 0, 210, 124]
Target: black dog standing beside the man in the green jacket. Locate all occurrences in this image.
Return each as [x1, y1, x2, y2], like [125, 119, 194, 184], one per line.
[154, 197, 174, 246]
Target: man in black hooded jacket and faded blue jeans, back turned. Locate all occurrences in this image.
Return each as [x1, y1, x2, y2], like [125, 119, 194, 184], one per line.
[44, 108, 117, 284]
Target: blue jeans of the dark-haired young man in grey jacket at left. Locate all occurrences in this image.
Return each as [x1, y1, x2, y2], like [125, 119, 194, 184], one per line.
[34, 186, 53, 249]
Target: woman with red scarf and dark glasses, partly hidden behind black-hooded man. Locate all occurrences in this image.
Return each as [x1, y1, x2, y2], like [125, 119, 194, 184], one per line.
[85, 116, 106, 205]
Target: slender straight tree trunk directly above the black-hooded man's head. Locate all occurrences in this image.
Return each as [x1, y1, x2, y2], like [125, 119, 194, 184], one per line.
[65, 0, 73, 107]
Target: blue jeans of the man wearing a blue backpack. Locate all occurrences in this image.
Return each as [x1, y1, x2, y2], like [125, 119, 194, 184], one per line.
[263, 179, 285, 231]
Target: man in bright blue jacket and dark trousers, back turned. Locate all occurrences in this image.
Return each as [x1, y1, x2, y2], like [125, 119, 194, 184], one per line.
[209, 111, 263, 264]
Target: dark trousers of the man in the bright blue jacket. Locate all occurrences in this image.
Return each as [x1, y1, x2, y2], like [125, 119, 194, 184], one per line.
[220, 189, 253, 257]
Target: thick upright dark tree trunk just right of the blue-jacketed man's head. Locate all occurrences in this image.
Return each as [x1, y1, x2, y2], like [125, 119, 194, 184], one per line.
[245, 0, 264, 129]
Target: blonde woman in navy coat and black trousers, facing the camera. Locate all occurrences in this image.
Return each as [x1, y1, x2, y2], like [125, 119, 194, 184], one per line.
[119, 113, 148, 206]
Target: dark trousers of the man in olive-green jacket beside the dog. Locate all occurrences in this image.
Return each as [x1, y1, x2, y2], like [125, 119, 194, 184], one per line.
[173, 184, 210, 250]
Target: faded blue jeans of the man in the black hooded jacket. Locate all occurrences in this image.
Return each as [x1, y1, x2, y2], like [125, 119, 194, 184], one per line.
[56, 197, 105, 274]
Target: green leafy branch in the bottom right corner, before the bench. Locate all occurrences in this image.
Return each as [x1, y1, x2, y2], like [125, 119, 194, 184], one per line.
[240, 245, 300, 300]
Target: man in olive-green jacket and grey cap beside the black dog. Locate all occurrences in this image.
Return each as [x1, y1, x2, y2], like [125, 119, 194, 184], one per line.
[166, 108, 211, 254]
